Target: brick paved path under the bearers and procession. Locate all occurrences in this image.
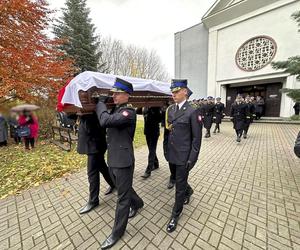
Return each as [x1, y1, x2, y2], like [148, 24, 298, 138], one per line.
[0, 123, 300, 250]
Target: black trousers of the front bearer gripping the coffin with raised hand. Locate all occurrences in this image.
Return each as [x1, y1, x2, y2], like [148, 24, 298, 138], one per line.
[109, 166, 144, 237]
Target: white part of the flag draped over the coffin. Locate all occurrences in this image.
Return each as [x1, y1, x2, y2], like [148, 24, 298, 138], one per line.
[61, 71, 171, 108]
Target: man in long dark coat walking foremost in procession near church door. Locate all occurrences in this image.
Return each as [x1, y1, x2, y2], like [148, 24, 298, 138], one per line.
[230, 96, 247, 142]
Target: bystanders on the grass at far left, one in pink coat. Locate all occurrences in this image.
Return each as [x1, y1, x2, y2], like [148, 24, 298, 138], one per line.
[0, 110, 39, 150]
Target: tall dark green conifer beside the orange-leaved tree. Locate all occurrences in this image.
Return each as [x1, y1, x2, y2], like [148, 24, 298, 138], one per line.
[53, 0, 102, 72]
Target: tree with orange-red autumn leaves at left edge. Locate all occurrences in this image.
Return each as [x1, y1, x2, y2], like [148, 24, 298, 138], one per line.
[0, 0, 73, 103]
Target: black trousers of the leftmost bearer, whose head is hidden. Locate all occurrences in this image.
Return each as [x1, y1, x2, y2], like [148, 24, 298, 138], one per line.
[87, 153, 114, 204]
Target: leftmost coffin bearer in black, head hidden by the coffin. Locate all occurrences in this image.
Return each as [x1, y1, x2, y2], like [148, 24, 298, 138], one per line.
[77, 113, 114, 214]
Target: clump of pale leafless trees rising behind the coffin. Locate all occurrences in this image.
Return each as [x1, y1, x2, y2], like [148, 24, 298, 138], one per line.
[99, 37, 169, 81]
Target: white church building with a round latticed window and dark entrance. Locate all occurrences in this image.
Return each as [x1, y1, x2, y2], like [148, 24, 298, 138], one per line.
[175, 0, 300, 117]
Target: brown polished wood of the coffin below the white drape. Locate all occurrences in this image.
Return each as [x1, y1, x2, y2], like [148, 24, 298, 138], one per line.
[64, 87, 173, 115]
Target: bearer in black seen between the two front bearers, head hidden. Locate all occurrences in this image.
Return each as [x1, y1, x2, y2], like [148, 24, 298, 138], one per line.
[142, 107, 162, 179]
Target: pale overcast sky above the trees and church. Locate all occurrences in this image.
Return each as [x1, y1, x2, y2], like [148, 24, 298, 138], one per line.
[48, 0, 215, 77]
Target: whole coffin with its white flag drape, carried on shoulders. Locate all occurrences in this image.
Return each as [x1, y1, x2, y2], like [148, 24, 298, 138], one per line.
[62, 71, 173, 114]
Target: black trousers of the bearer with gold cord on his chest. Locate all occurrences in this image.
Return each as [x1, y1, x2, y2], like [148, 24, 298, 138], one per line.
[169, 163, 192, 218]
